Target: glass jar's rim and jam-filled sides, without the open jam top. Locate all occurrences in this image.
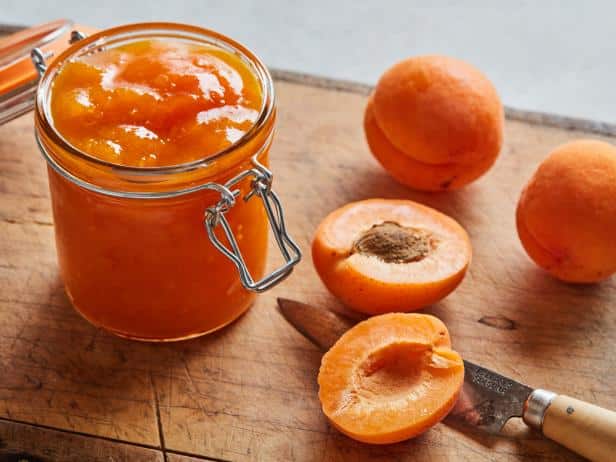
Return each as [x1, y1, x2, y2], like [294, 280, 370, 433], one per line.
[0, 23, 300, 341]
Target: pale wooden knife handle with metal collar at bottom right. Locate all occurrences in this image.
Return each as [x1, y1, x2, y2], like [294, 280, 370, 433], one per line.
[524, 390, 616, 462]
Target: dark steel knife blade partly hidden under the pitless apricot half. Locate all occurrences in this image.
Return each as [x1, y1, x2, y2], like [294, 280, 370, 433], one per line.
[278, 299, 533, 433]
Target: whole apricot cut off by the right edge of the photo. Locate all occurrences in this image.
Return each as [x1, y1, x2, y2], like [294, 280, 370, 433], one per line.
[516, 140, 616, 283]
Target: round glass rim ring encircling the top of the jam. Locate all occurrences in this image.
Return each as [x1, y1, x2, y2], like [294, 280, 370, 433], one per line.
[35, 22, 275, 176]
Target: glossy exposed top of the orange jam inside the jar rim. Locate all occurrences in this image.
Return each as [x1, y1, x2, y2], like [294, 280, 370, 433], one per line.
[51, 39, 263, 167]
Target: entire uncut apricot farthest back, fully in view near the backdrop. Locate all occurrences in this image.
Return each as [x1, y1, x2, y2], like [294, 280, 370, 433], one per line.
[364, 56, 504, 191]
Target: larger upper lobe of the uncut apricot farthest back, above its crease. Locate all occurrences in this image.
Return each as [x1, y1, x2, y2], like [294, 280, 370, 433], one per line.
[374, 56, 504, 164]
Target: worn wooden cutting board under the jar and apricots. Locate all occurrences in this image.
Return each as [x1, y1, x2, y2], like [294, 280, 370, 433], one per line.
[0, 72, 616, 462]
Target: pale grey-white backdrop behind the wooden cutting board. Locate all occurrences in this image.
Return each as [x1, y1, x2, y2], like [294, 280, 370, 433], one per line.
[0, 0, 616, 122]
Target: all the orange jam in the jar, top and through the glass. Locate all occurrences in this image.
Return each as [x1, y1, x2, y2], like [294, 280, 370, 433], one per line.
[42, 36, 274, 340]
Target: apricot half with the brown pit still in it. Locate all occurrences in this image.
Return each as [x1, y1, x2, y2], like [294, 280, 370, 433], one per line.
[312, 199, 472, 314]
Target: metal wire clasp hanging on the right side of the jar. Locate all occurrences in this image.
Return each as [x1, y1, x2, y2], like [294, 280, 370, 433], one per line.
[203, 156, 302, 292]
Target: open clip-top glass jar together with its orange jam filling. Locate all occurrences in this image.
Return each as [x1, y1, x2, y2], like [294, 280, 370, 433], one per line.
[35, 23, 299, 340]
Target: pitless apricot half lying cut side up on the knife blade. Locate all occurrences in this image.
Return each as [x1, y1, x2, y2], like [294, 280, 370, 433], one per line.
[318, 313, 464, 444]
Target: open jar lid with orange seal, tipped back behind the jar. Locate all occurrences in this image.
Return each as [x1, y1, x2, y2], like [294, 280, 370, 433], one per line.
[0, 19, 79, 125]
